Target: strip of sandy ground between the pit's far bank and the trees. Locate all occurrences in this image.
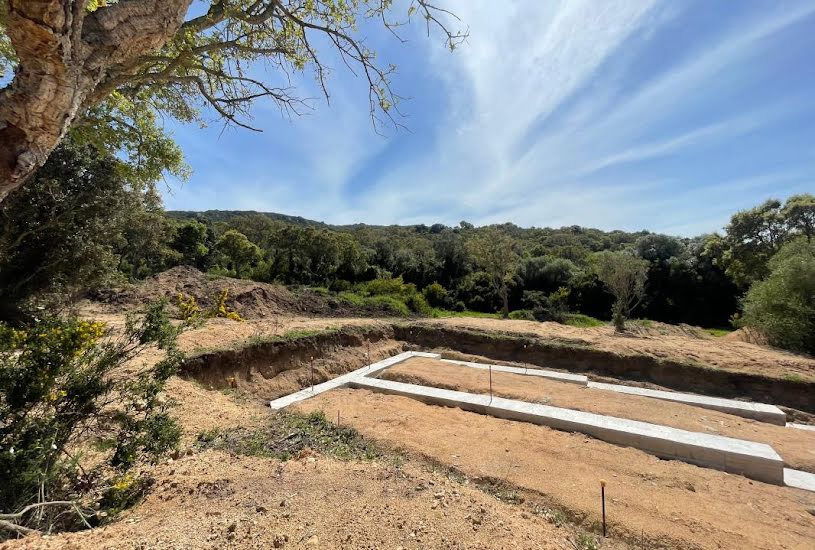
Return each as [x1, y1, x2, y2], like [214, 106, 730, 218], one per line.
[425, 317, 815, 379]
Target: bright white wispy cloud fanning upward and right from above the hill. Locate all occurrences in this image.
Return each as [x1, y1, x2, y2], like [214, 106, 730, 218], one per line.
[349, 0, 815, 235]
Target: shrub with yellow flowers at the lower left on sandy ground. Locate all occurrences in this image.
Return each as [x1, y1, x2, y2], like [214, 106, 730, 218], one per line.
[0, 304, 183, 531]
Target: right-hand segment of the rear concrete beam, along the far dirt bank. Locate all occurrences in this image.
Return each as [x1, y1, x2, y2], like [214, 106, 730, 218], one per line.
[588, 382, 787, 426]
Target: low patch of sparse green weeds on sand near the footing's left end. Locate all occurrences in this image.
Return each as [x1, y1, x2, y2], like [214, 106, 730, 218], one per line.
[196, 411, 383, 460]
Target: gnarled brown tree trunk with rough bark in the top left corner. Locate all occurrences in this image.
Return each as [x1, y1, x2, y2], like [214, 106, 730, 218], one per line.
[0, 0, 192, 202]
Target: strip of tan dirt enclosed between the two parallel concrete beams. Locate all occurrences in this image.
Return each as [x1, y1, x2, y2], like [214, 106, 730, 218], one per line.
[380, 357, 815, 472]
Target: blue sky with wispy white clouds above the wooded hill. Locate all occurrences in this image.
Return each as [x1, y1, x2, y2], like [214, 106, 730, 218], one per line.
[159, 0, 815, 236]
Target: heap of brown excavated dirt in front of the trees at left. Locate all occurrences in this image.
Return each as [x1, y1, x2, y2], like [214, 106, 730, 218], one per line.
[91, 266, 392, 319]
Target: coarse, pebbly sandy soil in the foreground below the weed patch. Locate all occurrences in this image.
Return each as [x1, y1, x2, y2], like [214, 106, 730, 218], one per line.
[0, 451, 625, 550]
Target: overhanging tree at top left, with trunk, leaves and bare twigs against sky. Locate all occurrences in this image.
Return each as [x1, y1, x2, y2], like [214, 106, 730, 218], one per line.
[0, 0, 466, 201]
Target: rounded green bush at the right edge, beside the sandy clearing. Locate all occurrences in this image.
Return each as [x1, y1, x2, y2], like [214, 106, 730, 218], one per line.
[738, 237, 815, 353]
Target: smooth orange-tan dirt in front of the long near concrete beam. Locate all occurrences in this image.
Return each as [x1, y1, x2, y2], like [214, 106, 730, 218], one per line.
[298, 389, 815, 550]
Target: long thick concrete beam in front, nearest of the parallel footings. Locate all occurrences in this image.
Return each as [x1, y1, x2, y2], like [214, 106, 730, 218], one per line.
[349, 377, 784, 485]
